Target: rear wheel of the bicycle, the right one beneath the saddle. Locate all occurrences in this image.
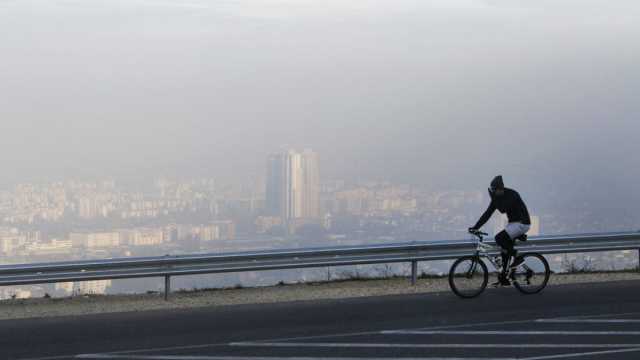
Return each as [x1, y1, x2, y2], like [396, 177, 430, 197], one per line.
[511, 253, 551, 294]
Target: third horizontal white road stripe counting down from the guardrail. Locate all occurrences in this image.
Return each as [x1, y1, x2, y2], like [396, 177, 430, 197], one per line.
[229, 342, 640, 349]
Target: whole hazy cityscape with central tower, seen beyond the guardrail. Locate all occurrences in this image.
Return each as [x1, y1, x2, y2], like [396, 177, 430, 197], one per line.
[0, 159, 637, 298]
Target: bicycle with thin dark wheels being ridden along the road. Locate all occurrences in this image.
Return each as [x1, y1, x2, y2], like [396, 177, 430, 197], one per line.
[449, 231, 551, 299]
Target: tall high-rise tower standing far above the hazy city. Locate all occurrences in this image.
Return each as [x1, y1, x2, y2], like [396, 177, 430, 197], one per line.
[266, 150, 320, 222]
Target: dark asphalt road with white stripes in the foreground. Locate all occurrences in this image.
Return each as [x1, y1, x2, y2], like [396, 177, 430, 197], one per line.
[0, 281, 640, 360]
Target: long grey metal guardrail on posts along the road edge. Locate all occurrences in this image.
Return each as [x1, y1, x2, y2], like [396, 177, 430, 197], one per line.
[0, 232, 640, 299]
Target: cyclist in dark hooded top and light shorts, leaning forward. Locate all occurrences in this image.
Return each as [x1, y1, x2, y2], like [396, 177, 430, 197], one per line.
[469, 175, 531, 285]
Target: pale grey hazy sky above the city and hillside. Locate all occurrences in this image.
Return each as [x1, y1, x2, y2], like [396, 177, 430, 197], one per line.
[0, 0, 640, 208]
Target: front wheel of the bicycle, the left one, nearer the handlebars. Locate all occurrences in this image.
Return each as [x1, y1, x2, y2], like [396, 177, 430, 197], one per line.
[449, 256, 489, 299]
